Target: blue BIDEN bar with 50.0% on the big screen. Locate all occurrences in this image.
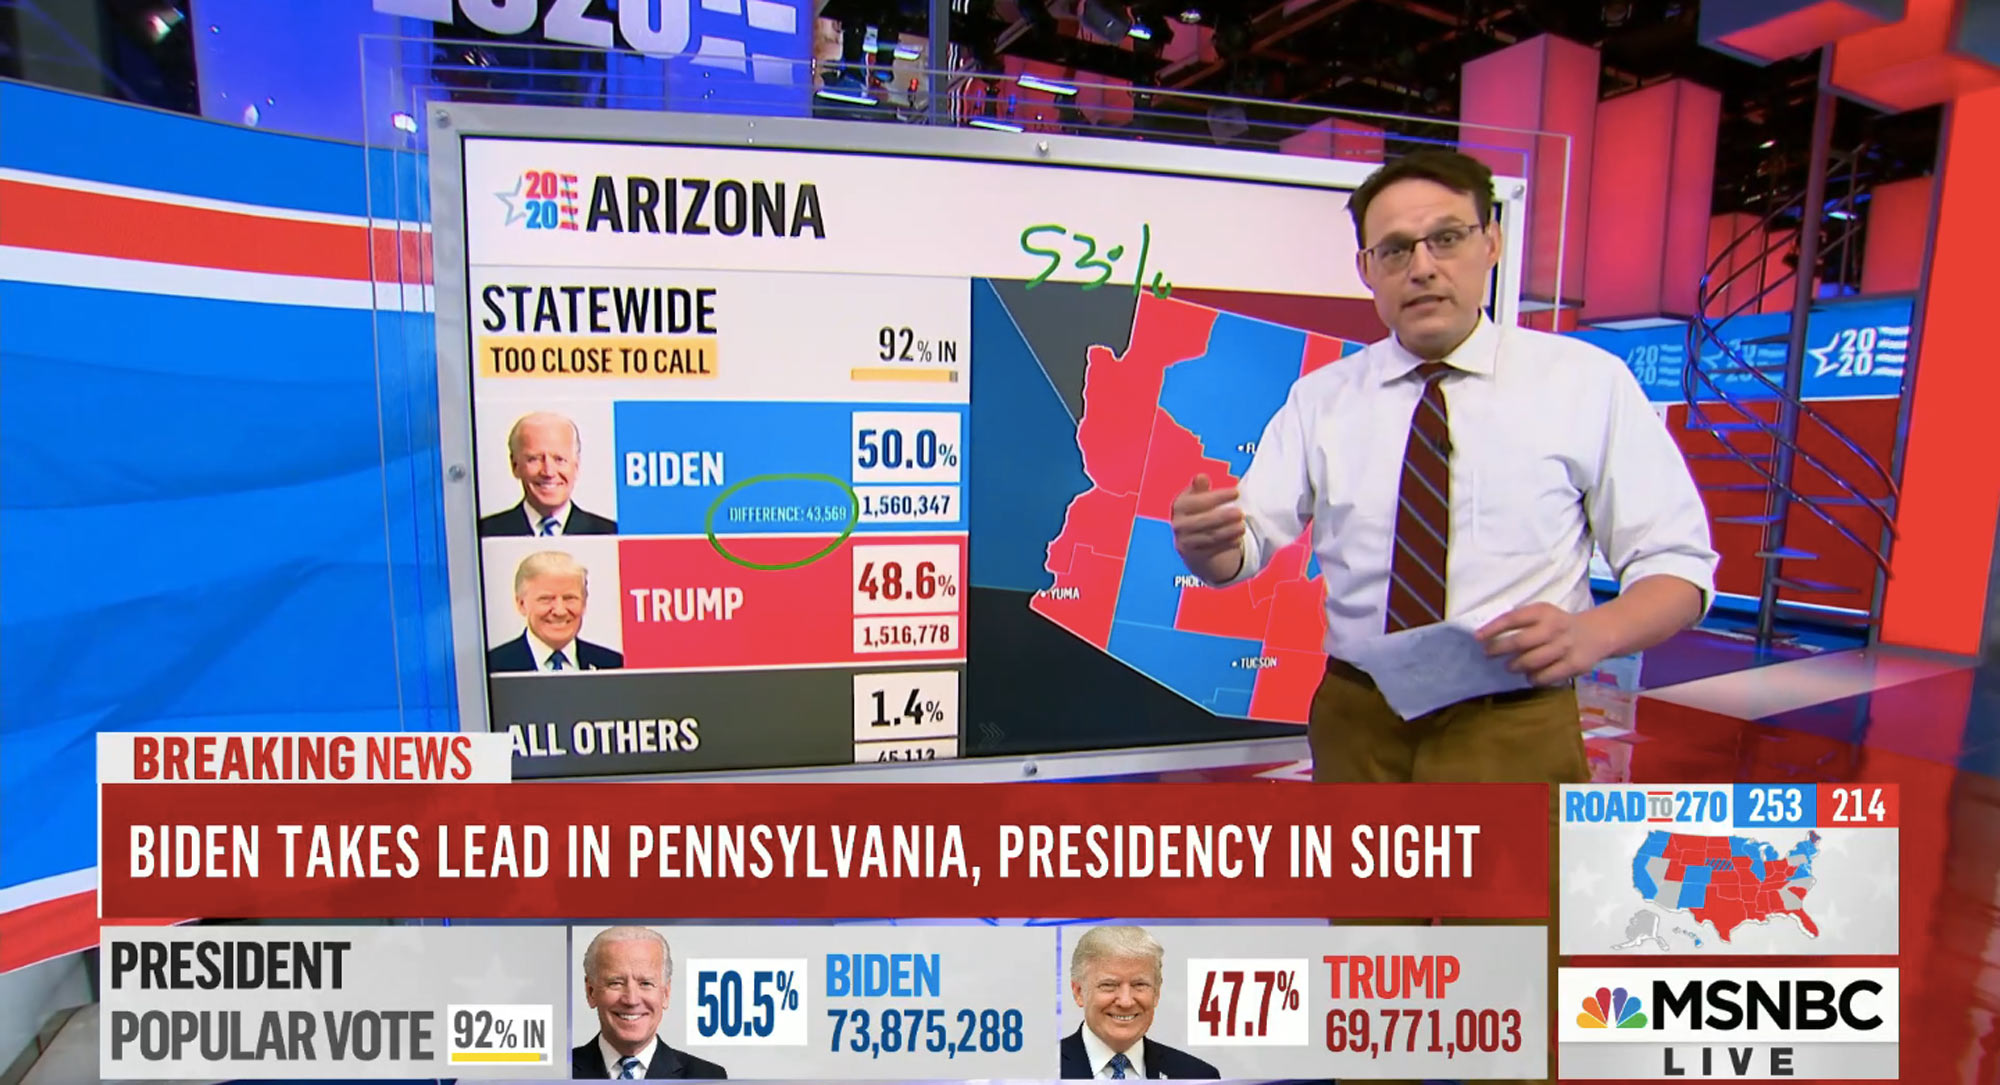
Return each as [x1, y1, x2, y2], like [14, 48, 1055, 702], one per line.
[612, 400, 970, 534]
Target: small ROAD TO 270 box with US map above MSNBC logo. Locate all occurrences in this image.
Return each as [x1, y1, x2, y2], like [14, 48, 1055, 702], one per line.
[1556, 783, 1902, 957]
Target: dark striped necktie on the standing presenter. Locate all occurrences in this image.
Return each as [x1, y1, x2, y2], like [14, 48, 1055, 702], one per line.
[1384, 362, 1452, 633]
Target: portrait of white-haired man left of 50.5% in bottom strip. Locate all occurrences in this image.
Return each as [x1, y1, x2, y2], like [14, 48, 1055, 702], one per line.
[570, 927, 728, 1081]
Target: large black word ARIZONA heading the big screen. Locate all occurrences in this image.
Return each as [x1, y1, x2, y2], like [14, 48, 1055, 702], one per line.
[584, 174, 826, 238]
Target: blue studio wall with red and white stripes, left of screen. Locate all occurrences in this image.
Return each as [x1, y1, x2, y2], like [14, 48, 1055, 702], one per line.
[0, 82, 452, 907]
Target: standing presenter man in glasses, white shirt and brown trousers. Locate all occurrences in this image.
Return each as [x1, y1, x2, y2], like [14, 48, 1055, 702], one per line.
[1172, 150, 1716, 783]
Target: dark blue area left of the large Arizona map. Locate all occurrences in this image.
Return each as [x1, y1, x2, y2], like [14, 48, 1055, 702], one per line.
[966, 278, 1090, 593]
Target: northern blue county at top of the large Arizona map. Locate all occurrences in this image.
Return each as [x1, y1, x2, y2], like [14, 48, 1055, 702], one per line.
[1160, 312, 1306, 476]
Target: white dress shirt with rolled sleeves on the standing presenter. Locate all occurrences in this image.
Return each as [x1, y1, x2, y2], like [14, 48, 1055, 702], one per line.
[1222, 310, 1718, 659]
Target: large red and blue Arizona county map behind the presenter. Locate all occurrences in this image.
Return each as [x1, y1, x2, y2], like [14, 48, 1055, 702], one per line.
[1030, 294, 1364, 723]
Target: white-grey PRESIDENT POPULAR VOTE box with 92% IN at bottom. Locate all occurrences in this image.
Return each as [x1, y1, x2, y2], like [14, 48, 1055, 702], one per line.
[98, 927, 570, 1081]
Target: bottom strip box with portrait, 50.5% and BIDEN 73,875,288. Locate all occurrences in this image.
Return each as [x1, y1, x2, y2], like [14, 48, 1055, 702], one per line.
[568, 925, 1058, 1081]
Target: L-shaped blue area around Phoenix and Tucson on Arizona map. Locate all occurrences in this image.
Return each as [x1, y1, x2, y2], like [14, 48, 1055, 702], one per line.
[1106, 518, 1264, 717]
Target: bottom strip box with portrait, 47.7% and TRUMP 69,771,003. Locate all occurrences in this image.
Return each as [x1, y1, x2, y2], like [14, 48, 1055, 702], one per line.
[1060, 928, 1548, 1079]
